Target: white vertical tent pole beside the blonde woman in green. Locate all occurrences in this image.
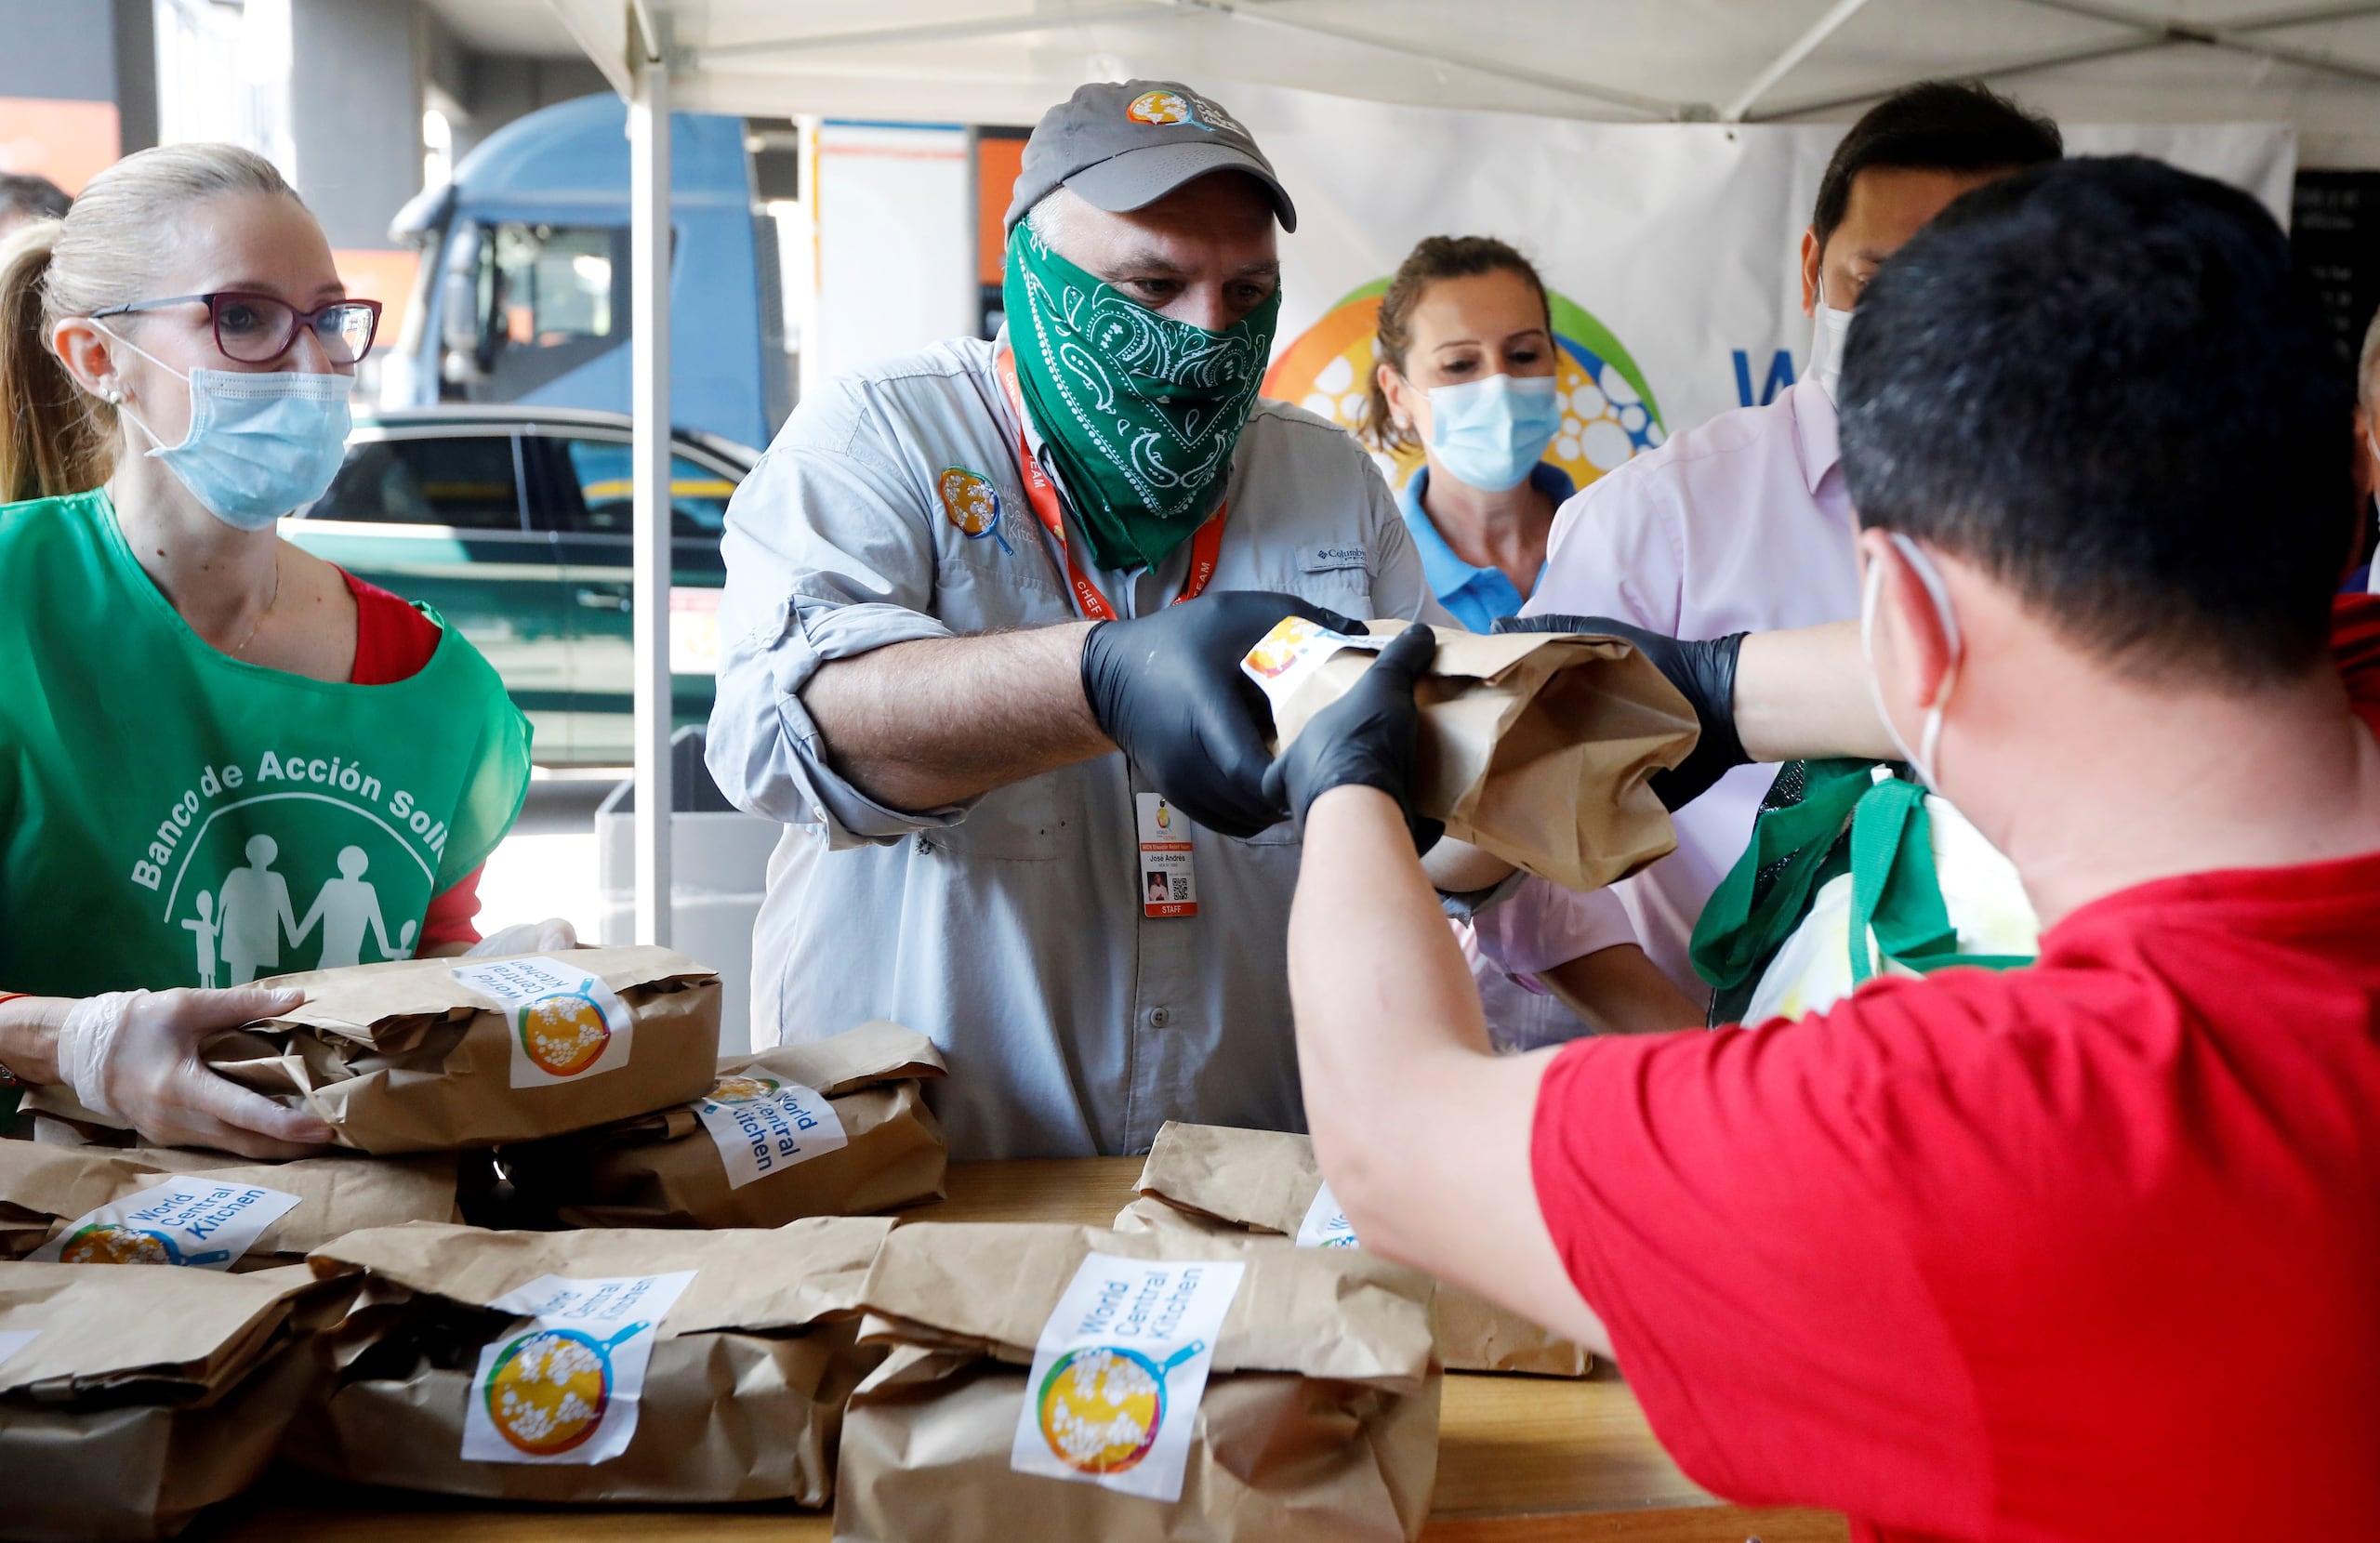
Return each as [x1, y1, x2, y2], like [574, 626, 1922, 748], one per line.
[628, 3, 673, 945]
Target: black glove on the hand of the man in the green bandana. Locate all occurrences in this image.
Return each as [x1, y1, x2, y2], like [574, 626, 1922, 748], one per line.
[1083, 590, 1364, 838]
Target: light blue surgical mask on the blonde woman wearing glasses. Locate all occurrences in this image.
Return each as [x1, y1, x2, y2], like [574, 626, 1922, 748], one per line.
[102, 329, 354, 531]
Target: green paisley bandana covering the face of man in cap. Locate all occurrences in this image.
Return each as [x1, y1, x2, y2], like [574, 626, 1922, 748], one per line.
[1002, 224, 1280, 569]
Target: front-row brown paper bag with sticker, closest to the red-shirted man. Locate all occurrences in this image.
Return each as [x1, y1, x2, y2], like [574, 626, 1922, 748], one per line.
[836, 1221, 1440, 1543]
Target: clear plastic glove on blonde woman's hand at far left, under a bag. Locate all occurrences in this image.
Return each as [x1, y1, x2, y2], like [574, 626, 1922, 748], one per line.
[57, 986, 331, 1157]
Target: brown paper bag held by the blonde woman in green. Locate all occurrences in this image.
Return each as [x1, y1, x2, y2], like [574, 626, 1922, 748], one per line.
[26, 948, 719, 1154]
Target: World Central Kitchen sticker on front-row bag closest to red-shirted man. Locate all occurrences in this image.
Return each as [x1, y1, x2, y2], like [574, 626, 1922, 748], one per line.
[1009, 1252, 1247, 1500]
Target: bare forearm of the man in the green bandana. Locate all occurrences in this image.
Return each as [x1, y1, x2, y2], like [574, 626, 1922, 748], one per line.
[802, 622, 1117, 810]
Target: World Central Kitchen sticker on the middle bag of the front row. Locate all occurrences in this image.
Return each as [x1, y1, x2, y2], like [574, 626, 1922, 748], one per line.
[462, 1269, 695, 1464]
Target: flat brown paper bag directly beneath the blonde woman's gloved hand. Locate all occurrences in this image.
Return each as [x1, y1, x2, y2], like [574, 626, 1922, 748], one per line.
[0, 1141, 457, 1272]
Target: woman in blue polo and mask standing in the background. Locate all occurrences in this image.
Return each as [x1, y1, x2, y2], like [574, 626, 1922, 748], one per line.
[1364, 236, 1573, 633]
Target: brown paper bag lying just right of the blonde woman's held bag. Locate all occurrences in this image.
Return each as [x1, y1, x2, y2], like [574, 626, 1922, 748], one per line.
[502, 1022, 947, 1226]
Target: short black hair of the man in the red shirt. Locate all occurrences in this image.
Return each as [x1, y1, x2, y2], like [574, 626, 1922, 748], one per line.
[1840, 157, 2356, 686]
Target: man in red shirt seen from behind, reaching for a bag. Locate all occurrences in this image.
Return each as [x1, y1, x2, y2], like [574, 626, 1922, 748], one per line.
[1276, 160, 2380, 1543]
